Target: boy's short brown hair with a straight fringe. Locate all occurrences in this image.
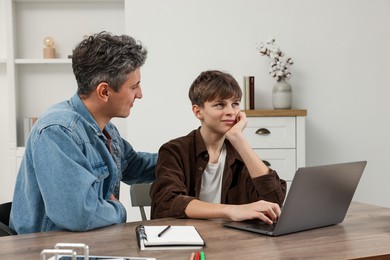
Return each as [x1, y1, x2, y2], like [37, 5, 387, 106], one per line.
[188, 70, 242, 107]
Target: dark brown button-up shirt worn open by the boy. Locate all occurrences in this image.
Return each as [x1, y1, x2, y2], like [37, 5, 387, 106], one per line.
[151, 128, 286, 219]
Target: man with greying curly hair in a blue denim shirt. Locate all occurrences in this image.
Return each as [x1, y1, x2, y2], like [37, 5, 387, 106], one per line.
[10, 32, 157, 234]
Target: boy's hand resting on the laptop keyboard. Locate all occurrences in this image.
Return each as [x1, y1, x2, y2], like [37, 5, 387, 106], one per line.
[225, 200, 281, 225]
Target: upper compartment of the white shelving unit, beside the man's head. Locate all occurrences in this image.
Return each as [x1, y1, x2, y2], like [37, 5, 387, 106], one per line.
[13, 0, 125, 61]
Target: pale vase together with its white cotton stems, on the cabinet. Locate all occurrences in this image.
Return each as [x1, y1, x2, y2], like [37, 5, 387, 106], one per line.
[257, 38, 294, 109]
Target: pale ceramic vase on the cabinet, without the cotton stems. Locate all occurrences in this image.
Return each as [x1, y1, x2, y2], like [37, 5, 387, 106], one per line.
[272, 79, 292, 109]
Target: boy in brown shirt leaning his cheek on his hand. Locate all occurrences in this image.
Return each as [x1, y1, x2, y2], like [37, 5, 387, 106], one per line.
[151, 71, 286, 224]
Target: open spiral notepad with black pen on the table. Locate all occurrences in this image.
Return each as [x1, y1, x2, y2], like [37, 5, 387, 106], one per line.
[136, 225, 205, 250]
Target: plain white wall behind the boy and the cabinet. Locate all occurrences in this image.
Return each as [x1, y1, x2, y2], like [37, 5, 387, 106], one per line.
[126, 0, 390, 207]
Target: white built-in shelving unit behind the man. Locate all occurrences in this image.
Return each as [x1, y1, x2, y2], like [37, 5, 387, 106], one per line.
[0, 0, 126, 195]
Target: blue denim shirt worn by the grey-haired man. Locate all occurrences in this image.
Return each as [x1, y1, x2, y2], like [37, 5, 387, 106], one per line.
[10, 94, 157, 234]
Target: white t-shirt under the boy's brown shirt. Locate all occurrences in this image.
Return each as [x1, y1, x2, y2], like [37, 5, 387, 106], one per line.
[199, 145, 226, 203]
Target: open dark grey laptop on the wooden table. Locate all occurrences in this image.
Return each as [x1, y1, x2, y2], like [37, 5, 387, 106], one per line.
[223, 161, 367, 236]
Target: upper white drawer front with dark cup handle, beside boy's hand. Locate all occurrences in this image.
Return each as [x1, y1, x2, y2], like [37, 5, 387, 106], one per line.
[244, 117, 296, 149]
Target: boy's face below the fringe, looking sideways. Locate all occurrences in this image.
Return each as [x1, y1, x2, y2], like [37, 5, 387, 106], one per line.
[193, 98, 240, 135]
